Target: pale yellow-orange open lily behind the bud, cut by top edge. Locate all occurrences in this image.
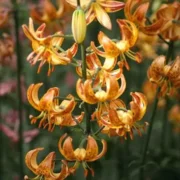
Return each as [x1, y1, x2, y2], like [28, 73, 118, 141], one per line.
[66, 0, 124, 29]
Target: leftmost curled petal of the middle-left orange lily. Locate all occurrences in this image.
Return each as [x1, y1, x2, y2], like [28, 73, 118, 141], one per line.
[27, 83, 43, 111]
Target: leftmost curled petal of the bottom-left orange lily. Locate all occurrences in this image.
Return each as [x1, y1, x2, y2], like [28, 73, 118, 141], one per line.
[25, 148, 44, 175]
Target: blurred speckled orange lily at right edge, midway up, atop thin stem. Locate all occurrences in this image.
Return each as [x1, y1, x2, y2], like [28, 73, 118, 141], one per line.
[148, 56, 180, 96]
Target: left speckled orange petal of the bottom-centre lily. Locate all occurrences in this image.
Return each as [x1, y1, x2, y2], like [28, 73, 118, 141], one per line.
[58, 134, 76, 161]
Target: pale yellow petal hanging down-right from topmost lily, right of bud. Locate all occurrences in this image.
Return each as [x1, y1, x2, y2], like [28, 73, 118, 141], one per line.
[91, 3, 112, 29]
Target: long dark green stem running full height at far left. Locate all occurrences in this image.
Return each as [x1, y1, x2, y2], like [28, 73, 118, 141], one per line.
[13, 1, 24, 179]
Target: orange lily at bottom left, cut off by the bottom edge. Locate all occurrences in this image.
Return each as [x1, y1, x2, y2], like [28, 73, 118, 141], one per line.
[24, 148, 69, 180]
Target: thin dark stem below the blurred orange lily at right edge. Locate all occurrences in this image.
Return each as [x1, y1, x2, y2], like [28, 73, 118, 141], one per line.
[140, 88, 160, 180]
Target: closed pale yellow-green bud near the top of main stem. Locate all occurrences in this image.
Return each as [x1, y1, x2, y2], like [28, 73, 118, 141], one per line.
[72, 7, 86, 44]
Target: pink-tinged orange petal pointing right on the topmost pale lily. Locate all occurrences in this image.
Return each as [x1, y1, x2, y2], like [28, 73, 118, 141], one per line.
[100, 1, 125, 12]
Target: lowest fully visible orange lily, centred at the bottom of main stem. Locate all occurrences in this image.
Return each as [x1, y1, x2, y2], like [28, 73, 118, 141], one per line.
[58, 134, 107, 176]
